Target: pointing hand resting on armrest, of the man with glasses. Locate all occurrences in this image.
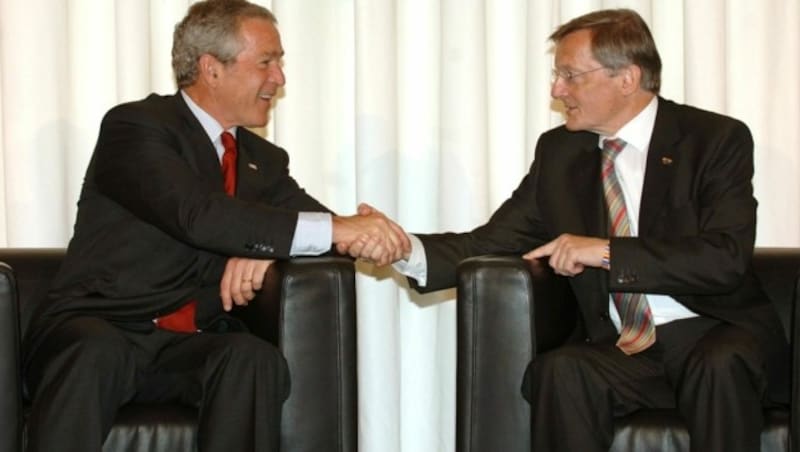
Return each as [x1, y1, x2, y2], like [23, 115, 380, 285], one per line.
[522, 234, 608, 276]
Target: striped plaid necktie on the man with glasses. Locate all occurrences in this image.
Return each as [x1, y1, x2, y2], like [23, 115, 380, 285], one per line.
[602, 138, 656, 355]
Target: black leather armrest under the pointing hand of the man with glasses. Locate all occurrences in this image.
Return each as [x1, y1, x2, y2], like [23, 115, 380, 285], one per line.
[456, 256, 577, 452]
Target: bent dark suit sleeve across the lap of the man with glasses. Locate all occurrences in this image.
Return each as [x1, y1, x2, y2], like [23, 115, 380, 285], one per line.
[609, 118, 757, 296]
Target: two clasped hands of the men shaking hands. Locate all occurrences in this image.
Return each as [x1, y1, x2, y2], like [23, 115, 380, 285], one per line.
[333, 204, 411, 266]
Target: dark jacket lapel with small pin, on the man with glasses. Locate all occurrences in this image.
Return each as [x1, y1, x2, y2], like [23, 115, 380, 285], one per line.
[639, 98, 681, 235]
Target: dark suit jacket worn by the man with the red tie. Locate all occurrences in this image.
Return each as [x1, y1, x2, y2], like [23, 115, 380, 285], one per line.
[29, 94, 327, 356]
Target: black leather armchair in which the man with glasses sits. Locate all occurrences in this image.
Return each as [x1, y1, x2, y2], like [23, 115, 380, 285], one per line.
[456, 248, 800, 452]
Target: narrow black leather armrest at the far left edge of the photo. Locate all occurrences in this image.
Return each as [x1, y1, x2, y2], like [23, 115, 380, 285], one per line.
[0, 262, 22, 452]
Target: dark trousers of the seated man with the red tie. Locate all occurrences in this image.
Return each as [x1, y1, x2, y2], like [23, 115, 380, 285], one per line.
[25, 317, 289, 452]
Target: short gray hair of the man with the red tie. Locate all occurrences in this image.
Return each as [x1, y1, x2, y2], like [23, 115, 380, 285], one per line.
[172, 0, 278, 88]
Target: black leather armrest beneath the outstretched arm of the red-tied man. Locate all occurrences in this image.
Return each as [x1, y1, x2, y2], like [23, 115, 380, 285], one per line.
[239, 257, 358, 452]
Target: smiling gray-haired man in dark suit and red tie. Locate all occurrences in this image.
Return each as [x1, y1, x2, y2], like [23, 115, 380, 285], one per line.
[25, 0, 408, 452]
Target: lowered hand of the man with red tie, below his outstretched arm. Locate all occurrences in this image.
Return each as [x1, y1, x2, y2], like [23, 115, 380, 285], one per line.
[219, 257, 275, 311]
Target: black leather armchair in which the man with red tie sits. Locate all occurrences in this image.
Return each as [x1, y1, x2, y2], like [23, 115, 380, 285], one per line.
[0, 249, 358, 452]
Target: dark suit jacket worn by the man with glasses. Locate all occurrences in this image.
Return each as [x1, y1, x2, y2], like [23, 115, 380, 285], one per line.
[411, 99, 788, 392]
